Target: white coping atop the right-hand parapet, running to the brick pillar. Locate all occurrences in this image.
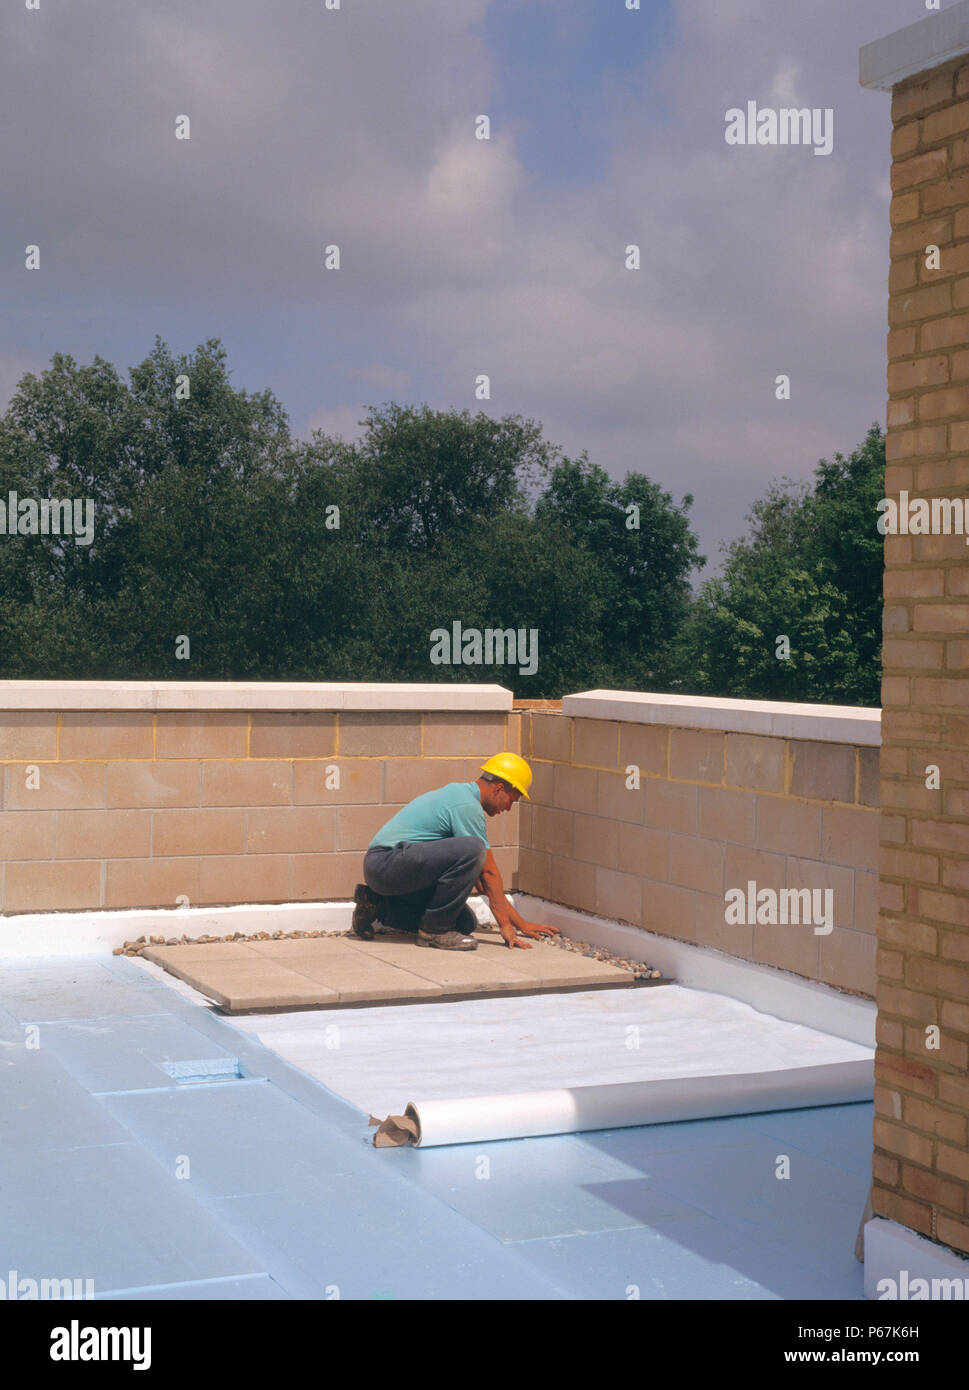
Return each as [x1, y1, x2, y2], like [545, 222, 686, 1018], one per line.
[562, 691, 881, 748]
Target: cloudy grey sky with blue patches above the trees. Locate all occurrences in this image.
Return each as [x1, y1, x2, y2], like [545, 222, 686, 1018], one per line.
[0, 0, 926, 574]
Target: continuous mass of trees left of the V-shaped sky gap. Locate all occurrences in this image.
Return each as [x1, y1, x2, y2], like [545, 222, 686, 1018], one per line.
[0, 339, 702, 698]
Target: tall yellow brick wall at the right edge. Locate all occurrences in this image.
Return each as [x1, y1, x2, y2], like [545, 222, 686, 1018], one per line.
[873, 58, 969, 1251]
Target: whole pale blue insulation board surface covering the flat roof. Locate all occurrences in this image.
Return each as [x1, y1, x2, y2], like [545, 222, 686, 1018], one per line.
[0, 956, 873, 1300]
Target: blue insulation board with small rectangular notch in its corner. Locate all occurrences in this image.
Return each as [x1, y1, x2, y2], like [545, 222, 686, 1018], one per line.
[40, 1013, 238, 1093]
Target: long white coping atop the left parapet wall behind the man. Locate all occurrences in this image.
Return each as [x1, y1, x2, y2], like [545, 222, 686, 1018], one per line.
[0, 681, 514, 712]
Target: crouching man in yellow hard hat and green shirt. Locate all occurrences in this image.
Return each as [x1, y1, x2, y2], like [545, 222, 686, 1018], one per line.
[353, 753, 557, 951]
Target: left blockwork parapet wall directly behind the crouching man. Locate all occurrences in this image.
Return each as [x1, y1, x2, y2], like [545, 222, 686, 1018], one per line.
[0, 682, 520, 916]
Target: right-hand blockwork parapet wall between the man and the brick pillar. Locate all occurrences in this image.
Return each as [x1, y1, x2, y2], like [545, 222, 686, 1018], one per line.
[517, 692, 879, 997]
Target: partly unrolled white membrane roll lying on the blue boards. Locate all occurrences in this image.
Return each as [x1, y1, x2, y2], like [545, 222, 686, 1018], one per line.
[405, 1059, 874, 1148]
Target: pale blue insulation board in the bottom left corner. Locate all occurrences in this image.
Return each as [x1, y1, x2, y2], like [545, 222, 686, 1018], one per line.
[0, 1141, 266, 1294]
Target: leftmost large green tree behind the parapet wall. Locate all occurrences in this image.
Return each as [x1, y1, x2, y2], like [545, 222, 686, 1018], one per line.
[0, 341, 292, 680]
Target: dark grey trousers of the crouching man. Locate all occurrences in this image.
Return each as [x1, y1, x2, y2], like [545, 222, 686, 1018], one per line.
[363, 835, 488, 935]
